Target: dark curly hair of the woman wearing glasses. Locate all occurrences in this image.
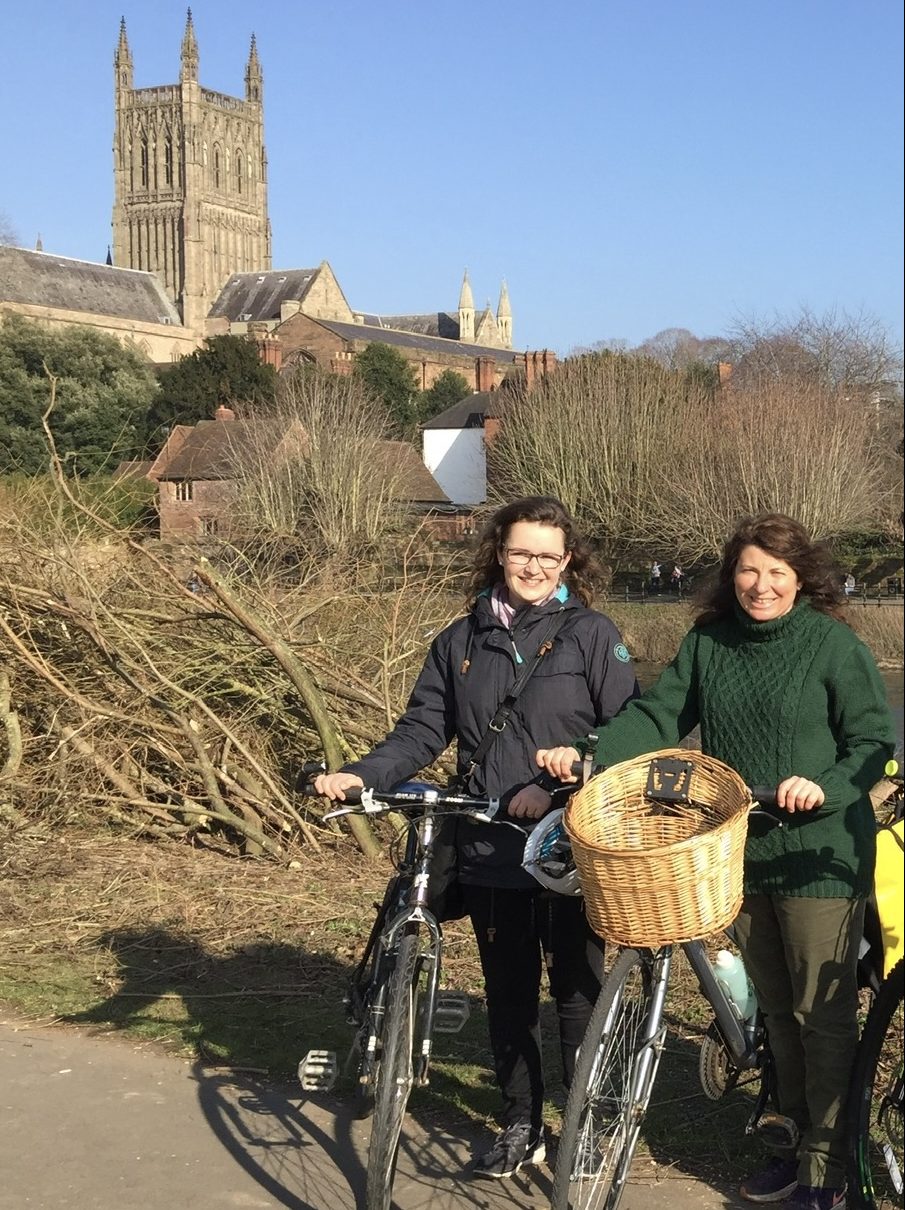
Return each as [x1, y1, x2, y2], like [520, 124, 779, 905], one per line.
[468, 496, 603, 605]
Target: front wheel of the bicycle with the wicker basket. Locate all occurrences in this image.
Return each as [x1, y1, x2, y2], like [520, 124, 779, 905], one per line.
[552, 950, 662, 1210]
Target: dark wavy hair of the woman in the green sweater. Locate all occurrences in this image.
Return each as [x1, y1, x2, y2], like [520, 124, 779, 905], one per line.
[694, 513, 845, 626]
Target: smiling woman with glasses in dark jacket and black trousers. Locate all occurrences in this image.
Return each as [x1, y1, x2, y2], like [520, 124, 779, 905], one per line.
[316, 496, 638, 1177]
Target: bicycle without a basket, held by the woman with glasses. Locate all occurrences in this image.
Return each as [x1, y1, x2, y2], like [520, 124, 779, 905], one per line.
[306, 770, 519, 1210]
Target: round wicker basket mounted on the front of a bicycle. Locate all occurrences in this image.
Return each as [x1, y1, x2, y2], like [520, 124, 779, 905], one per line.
[564, 748, 751, 949]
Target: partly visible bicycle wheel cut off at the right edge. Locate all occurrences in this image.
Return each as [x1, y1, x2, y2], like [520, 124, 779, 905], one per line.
[848, 960, 905, 1210]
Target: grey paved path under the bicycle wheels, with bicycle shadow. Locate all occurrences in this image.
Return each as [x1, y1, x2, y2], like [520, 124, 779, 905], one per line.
[0, 1009, 744, 1210]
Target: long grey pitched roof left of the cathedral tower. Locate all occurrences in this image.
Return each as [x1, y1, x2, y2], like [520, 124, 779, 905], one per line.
[0, 247, 181, 327]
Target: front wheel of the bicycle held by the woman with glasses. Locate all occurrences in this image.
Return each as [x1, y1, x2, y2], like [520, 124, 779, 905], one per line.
[367, 927, 420, 1210]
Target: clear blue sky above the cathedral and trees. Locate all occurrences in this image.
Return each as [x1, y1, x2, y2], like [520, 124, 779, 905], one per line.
[0, 0, 903, 355]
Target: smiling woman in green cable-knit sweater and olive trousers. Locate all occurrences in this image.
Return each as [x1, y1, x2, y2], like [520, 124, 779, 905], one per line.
[537, 513, 894, 1210]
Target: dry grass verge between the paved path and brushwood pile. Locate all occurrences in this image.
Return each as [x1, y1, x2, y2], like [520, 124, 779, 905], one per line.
[0, 828, 774, 1180]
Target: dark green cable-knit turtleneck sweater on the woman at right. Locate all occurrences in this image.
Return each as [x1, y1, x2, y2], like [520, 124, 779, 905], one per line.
[578, 600, 894, 898]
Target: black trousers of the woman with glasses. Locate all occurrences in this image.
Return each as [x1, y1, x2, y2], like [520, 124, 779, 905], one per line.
[462, 886, 604, 1128]
